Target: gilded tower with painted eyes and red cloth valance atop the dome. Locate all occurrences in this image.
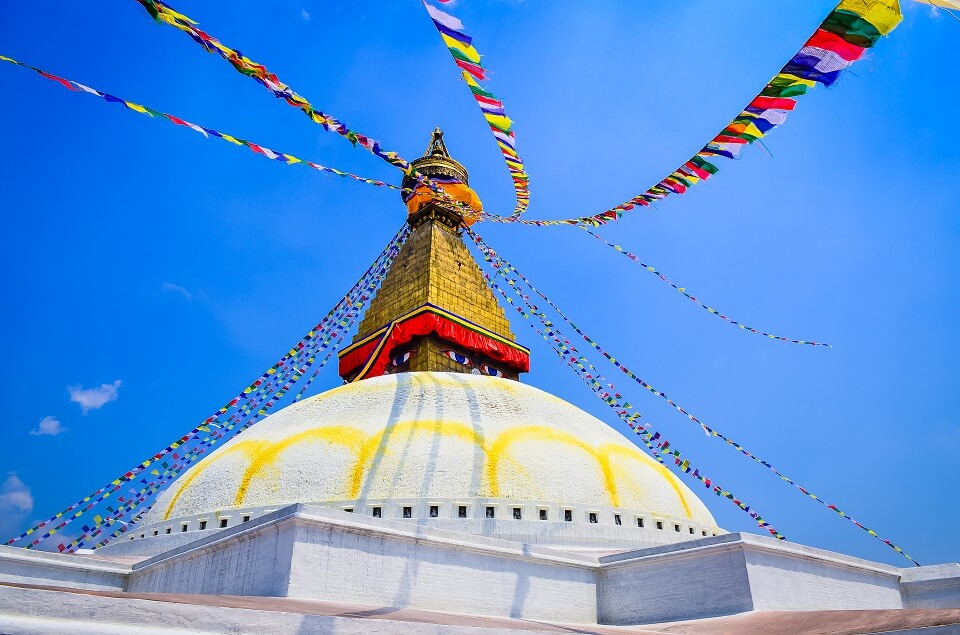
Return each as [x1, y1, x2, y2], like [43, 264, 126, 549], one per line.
[340, 128, 530, 382]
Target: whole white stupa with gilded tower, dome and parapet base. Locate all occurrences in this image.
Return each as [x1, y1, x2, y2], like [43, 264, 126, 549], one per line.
[0, 130, 960, 633]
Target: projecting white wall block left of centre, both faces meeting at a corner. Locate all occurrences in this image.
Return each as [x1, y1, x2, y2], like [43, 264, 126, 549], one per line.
[126, 505, 597, 623]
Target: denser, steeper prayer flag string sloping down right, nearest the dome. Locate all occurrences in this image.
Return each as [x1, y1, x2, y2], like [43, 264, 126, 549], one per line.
[467, 228, 786, 540]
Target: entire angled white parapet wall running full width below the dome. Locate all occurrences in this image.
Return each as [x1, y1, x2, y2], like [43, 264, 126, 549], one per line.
[0, 505, 960, 625]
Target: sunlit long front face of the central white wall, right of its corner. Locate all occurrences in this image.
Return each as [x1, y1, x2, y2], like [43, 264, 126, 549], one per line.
[289, 512, 597, 623]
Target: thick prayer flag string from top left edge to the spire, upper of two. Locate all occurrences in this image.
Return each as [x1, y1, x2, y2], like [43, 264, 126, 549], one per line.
[136, 0, 477, 224]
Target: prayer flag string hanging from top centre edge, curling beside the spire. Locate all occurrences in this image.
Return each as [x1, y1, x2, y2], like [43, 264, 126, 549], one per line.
[423, 0, 530, 219]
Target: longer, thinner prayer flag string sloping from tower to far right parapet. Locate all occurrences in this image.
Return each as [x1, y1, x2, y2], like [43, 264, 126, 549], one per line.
[467, 228, 920, 566]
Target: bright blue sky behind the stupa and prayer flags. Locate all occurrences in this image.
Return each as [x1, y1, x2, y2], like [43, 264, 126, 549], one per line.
[0, 0, 960, 565]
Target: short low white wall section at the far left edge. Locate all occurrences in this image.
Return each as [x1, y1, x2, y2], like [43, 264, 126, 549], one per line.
[0, 546, 130, 590]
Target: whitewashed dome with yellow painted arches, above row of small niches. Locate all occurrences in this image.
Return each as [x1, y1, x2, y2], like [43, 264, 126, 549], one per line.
[144, 372, 716, 533]
